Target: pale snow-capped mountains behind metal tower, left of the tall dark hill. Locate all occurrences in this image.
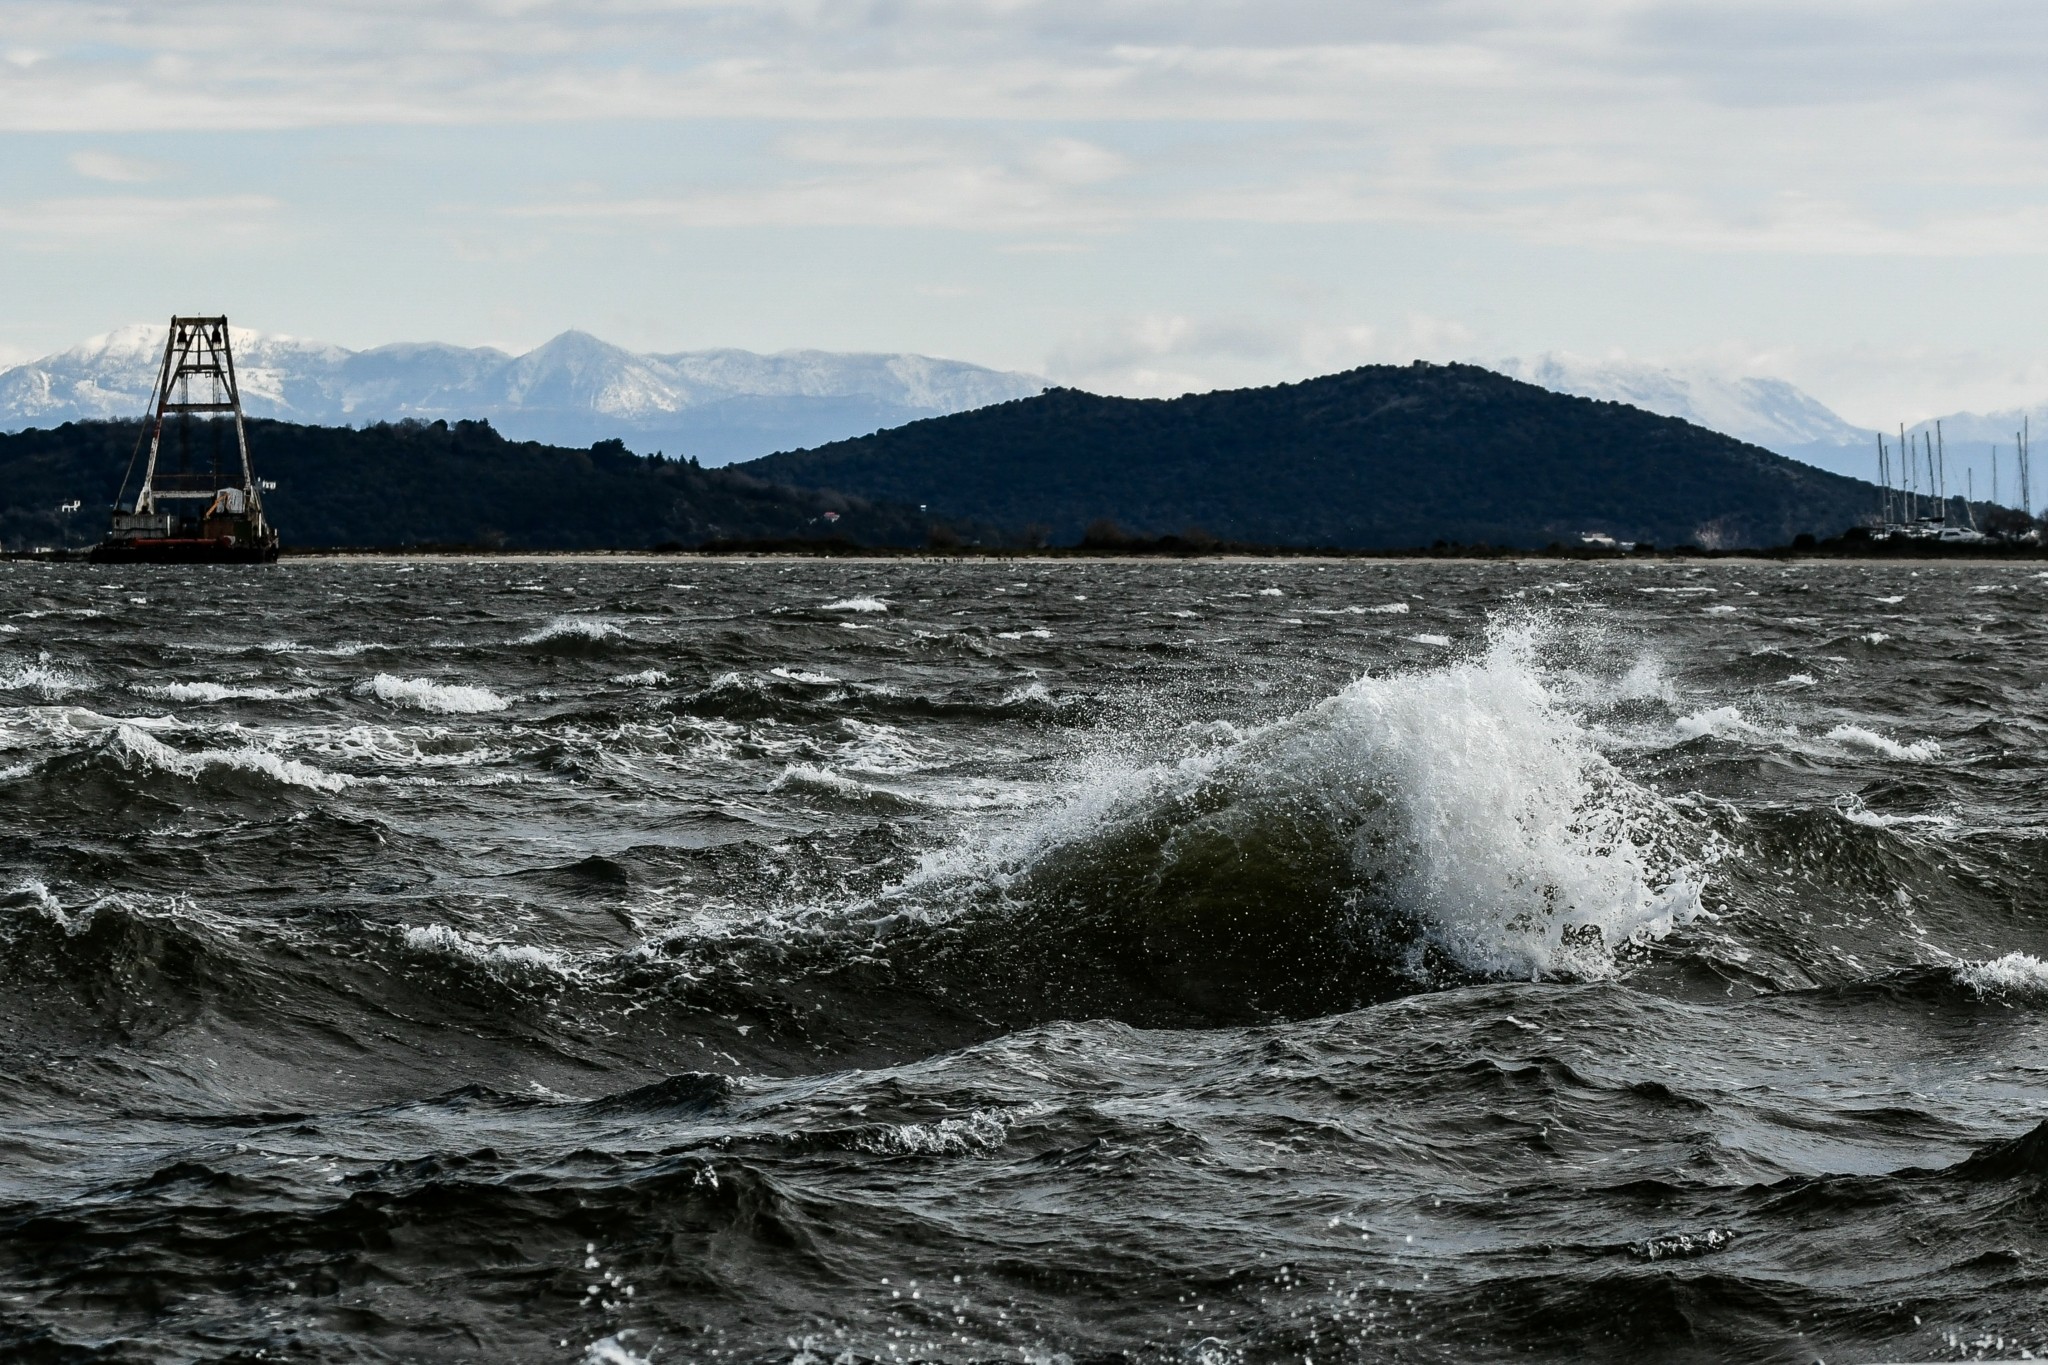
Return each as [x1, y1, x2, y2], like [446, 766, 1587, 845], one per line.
[0, 323, 1044, 465]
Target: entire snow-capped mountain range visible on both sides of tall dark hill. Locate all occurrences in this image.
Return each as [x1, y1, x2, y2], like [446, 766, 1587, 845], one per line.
[0, 323, 2048, 515]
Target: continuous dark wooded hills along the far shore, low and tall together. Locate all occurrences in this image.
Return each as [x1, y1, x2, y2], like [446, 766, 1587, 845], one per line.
[0, 362, 1878, 548]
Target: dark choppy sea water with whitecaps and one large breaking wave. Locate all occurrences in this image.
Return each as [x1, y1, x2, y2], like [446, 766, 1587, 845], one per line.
[0, 561, 2048, 1365]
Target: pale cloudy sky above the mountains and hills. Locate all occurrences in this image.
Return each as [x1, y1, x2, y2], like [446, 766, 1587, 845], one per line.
[0, 0, 2048, 426]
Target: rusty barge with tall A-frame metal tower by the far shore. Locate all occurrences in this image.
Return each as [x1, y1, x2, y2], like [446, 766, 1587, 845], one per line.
[90, 317, 279, 565]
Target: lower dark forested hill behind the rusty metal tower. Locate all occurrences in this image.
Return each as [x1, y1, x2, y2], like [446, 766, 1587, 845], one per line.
[0, 420, 926, 548]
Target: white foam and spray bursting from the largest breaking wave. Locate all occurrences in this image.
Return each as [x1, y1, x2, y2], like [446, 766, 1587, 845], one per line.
[921, 626, 1706, 976]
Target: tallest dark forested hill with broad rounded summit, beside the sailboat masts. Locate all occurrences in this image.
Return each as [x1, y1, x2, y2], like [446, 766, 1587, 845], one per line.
[735, 362, 1878, 548]
